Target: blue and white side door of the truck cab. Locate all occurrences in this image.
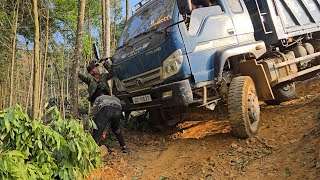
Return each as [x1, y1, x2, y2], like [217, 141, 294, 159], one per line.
[184, 0, 238, 83]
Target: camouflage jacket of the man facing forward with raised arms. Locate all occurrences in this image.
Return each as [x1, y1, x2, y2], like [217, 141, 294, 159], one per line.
[78, 73, 112, 101]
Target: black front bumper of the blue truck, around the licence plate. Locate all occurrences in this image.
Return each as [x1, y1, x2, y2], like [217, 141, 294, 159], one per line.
[117, 79, 193, 111]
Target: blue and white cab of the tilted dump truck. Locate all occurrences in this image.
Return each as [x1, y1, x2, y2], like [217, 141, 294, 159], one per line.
[113, 0, 265, 110]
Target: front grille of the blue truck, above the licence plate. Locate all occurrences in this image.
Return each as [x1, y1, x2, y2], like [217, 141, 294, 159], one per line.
[122, 67, 163, 92]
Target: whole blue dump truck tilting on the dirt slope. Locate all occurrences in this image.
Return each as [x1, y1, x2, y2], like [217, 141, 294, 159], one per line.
[96, 0, 320, 138]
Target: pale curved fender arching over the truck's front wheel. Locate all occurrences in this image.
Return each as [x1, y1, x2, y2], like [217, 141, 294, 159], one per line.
[214, 41, 267, 80]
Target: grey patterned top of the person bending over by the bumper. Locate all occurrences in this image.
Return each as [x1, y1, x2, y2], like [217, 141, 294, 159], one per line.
[90, 95, 121, 119]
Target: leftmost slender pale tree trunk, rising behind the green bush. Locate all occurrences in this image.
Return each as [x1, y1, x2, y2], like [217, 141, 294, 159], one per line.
[9, 2, 19, 107]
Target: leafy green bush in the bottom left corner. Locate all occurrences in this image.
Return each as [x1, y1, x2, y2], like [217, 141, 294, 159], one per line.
[0, 105, 101, 179]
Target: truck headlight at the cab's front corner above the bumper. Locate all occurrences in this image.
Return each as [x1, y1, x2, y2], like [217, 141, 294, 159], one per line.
[162, 49, 183, 79]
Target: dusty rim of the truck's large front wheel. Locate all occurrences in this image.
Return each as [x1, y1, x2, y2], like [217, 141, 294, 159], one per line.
[248, 91, 260, 131]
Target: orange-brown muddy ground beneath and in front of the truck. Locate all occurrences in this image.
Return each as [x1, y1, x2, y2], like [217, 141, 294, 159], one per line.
[89, 76, 320, 180]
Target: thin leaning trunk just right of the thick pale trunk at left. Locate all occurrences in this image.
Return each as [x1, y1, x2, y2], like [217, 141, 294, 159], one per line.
[40, 6, 50, 117]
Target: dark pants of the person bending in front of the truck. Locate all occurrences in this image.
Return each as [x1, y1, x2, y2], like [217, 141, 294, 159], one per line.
[92, 106, 125, 146]
